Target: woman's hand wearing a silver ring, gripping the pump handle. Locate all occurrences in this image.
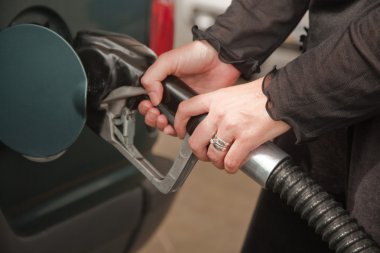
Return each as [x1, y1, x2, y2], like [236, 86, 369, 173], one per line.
[174, 78, 290, 173]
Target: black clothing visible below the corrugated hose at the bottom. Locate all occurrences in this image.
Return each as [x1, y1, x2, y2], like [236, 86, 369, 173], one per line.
[241, 190, 334, 253]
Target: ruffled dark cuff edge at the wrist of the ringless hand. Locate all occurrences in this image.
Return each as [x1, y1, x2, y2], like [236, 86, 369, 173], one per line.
[191, 26, 260, 80]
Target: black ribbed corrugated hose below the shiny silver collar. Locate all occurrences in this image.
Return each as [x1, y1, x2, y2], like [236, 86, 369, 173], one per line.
[266, 159, 380, 253]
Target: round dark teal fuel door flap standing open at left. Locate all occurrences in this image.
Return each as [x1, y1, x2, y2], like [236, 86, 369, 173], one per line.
[0, 24, 87, 158]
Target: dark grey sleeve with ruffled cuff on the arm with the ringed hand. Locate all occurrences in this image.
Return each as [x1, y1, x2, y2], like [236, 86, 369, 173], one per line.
[263, 3, 380, 142]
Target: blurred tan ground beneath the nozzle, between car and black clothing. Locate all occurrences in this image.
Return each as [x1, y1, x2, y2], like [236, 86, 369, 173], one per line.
[138, 134, 260, 253]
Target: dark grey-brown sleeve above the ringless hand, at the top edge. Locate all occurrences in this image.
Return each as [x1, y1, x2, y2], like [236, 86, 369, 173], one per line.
[193, 0, 309, 79]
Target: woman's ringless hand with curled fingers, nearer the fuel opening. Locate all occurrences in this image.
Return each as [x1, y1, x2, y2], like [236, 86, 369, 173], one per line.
[139, 41, 240, 135]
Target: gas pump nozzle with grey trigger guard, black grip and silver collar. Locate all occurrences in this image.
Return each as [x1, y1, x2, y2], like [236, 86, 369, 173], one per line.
[75, 32, 288, 193]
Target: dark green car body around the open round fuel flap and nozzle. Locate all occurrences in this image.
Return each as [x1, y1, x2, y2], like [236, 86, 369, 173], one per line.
[0, 0, 174, 253]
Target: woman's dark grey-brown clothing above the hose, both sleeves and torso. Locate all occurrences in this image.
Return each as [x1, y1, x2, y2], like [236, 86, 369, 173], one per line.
[194, 0, 380, 249]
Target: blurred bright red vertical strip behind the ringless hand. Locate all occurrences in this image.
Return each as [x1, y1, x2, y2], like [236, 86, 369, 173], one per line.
[149, 0, 174, 55]
